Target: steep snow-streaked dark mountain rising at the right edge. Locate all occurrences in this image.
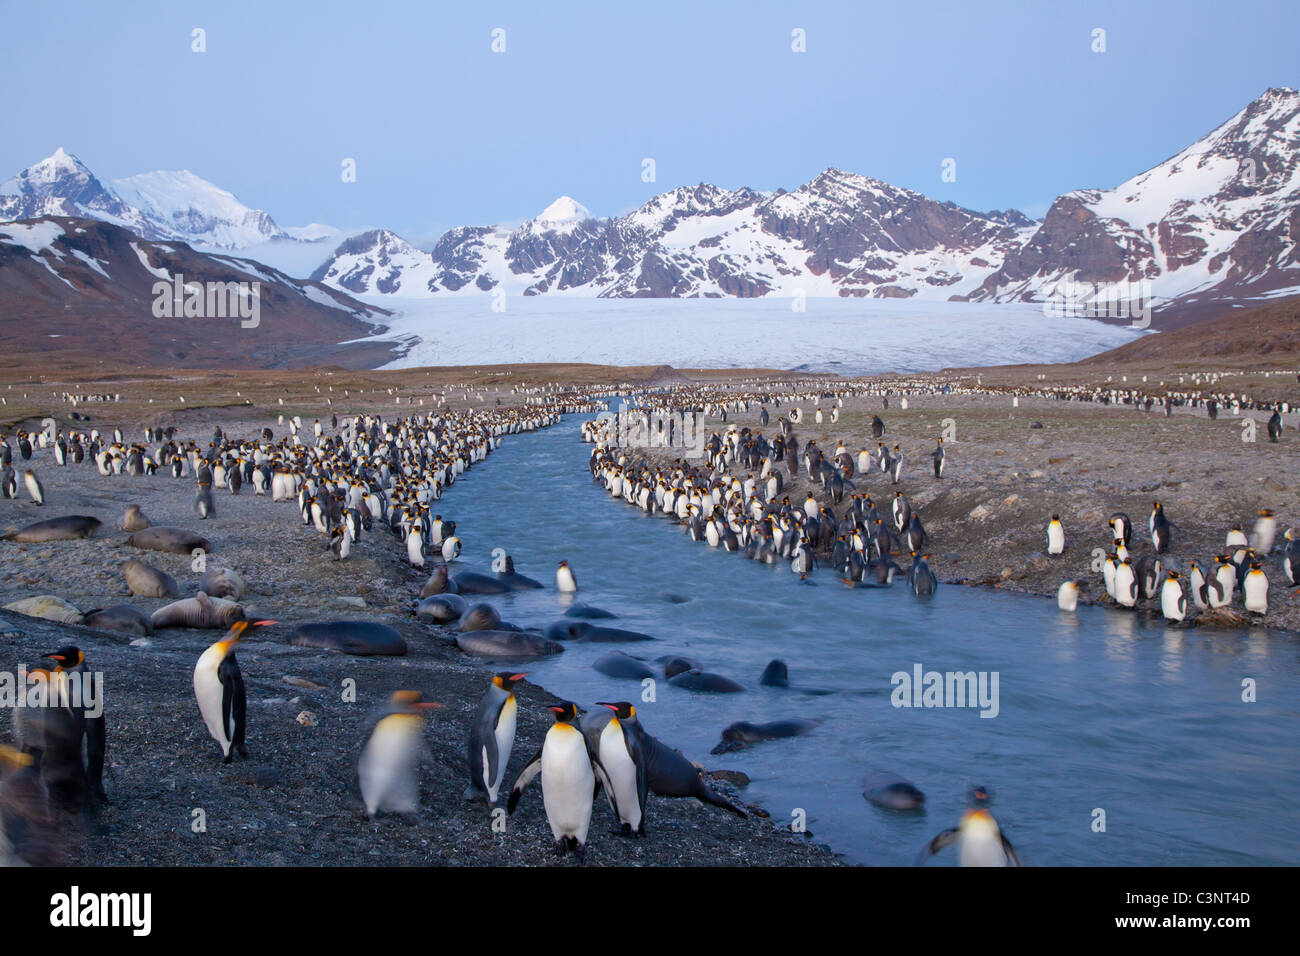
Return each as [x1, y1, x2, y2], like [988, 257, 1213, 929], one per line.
[971, 88, 1300, 312]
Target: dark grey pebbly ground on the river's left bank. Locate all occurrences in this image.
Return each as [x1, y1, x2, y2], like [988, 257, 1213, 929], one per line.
[0, 410, 839, 866]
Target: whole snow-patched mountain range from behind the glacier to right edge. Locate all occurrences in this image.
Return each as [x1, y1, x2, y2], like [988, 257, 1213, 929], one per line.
[313, 88, 1300, 316]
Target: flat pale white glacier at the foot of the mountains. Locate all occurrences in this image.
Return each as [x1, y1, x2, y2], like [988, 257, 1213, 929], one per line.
[365, 295, 1144, 375]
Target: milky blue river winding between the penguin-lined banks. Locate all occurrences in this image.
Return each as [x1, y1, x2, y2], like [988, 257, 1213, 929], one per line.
[441, 416, 1300, 866]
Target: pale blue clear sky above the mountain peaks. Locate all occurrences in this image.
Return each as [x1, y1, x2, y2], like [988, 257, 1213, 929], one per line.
[0, 0, 1300, 239]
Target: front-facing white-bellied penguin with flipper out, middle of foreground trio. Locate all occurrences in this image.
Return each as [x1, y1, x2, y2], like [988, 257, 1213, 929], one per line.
[507, 701, 595, 861]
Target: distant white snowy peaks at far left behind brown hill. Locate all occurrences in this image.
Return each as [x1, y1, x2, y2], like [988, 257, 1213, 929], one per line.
[0, 147, 339, 248]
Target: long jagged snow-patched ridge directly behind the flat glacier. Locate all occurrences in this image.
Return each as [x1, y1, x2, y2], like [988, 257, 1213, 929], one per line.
[312, 169, 1034, 299]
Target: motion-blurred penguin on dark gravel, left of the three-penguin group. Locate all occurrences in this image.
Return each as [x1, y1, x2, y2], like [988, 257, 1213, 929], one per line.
[356, 691, 442, 819]
